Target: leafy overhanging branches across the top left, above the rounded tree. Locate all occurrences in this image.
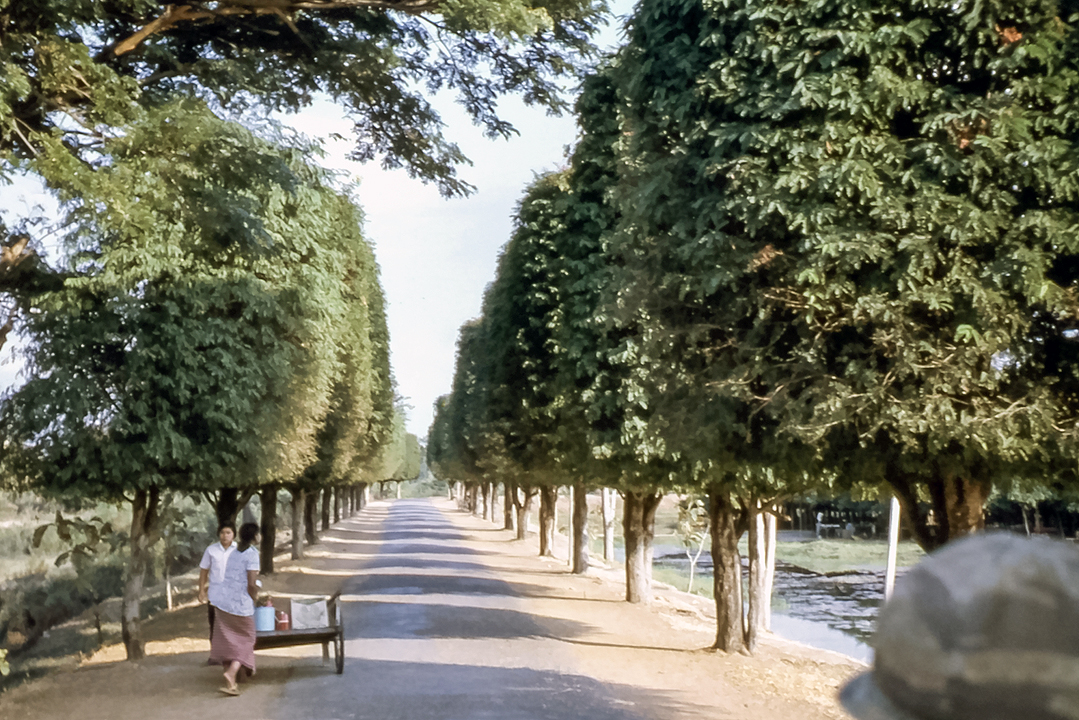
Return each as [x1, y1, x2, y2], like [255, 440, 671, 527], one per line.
[0, 0, 605, 195]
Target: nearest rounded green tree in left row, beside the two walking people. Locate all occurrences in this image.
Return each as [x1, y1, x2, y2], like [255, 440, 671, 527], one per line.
[2, 104, 379, 658]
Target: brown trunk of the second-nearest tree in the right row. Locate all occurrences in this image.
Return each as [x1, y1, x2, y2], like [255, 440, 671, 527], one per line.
[708, 484, 746, 653]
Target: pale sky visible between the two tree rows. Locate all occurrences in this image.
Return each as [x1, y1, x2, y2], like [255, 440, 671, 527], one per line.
[0, 0, 631, 438]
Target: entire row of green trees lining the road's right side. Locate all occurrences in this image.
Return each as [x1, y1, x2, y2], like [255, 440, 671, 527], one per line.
[428, 0, 1079, 651]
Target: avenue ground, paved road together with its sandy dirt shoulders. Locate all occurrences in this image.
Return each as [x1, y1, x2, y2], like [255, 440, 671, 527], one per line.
[0, 500, 858, 720]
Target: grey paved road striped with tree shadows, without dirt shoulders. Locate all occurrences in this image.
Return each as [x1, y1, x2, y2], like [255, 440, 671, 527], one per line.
[275, 501, 668, 720]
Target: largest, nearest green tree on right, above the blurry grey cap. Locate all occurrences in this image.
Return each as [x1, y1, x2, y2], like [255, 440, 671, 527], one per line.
[630, 1, 1079, 548]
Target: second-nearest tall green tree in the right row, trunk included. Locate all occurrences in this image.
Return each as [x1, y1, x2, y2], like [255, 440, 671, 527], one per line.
[592, 0, 819, 652]
